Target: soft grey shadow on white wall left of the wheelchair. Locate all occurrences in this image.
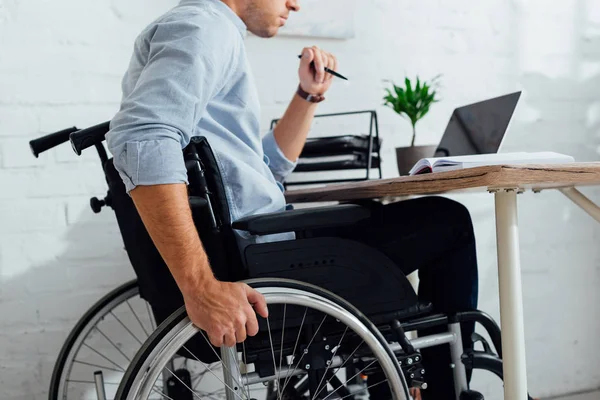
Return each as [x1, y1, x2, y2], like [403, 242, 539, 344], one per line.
[0, 207, 135, 400]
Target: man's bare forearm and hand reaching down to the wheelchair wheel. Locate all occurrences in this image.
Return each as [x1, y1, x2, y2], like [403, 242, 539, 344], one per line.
[130, 184, 268, 347]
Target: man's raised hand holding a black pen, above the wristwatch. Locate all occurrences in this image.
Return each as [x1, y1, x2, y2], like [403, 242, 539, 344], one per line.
[298, 46, 338, 95]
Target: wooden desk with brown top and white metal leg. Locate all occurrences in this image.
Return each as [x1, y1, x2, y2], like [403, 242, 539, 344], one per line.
[286, 163, 600, 400]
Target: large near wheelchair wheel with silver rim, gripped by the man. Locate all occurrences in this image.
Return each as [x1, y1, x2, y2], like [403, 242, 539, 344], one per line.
[115, 279, 409, 400]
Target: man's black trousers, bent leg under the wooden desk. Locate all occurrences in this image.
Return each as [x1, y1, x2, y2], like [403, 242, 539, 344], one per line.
[316, 197, 478, 400]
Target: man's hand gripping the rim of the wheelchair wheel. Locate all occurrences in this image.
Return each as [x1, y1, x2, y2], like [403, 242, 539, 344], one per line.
[183, 279, 268, 347]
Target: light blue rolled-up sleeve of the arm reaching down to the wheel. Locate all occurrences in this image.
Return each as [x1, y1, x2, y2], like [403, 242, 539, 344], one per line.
[106, 20, 223, 192]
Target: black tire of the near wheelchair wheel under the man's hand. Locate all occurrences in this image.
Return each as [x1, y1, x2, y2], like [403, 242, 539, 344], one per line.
[115, 278, 409, 400]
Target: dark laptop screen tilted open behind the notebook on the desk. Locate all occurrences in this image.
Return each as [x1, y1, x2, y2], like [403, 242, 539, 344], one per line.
[435, 92, 521, 157]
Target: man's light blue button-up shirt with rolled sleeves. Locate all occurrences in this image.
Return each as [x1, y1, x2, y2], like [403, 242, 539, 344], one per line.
[106, 0, 295, 241]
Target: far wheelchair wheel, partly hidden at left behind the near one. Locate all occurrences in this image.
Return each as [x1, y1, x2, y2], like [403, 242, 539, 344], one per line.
[49, 280, 156, 400]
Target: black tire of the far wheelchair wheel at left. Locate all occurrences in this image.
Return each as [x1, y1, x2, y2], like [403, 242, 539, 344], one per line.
[48, 279, 139, 400]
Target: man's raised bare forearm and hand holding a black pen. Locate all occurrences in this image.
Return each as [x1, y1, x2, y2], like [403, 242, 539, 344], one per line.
[273, 47, 338, 162]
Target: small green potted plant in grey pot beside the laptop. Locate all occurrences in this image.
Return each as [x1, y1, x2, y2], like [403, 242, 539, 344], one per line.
[383, 77, 439, 175]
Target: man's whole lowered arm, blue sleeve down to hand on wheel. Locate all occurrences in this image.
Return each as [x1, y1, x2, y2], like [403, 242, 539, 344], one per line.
[107, 20, 267, 347]
